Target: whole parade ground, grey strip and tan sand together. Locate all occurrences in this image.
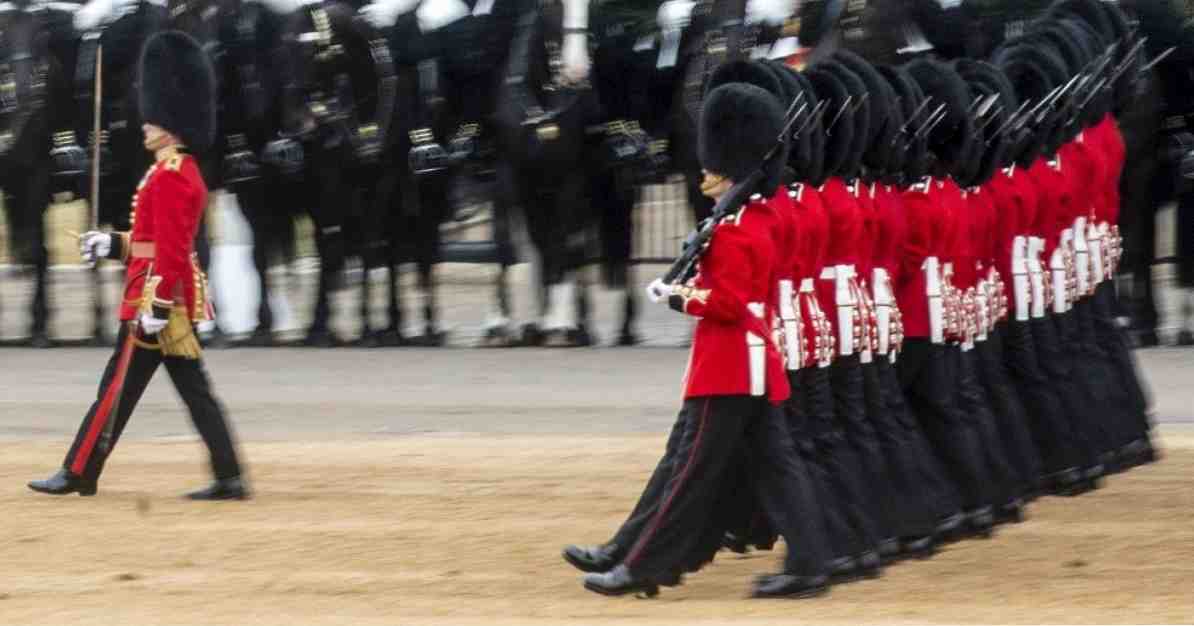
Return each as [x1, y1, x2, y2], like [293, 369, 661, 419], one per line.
[0, 349, 1194, 625]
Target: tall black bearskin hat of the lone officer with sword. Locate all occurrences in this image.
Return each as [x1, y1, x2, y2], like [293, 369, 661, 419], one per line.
[137, 30, 216, 152]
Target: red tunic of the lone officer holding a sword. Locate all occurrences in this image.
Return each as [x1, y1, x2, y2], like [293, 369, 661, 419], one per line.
[112, 154, 210, 321]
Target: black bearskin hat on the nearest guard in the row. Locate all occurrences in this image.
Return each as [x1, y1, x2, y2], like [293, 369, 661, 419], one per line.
[697, 82, 787, 194]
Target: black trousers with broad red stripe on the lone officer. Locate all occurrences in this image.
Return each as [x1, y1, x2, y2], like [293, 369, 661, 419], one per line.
[62, 325, 240, 479]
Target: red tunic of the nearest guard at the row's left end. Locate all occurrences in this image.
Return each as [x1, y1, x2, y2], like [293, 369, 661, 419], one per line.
[673, 201, 790, 403]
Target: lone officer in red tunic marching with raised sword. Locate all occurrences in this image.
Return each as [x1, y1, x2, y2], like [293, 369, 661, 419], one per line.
[29, 31, 248, 499]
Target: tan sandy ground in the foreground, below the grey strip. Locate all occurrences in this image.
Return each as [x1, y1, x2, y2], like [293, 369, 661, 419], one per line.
[0, 430, 1194, 625]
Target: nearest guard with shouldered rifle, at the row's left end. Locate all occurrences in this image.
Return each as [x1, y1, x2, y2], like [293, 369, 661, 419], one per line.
[566, 82, 827, 597]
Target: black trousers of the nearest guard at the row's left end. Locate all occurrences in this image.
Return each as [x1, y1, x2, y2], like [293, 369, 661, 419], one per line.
[620, 395, 827, 578]
